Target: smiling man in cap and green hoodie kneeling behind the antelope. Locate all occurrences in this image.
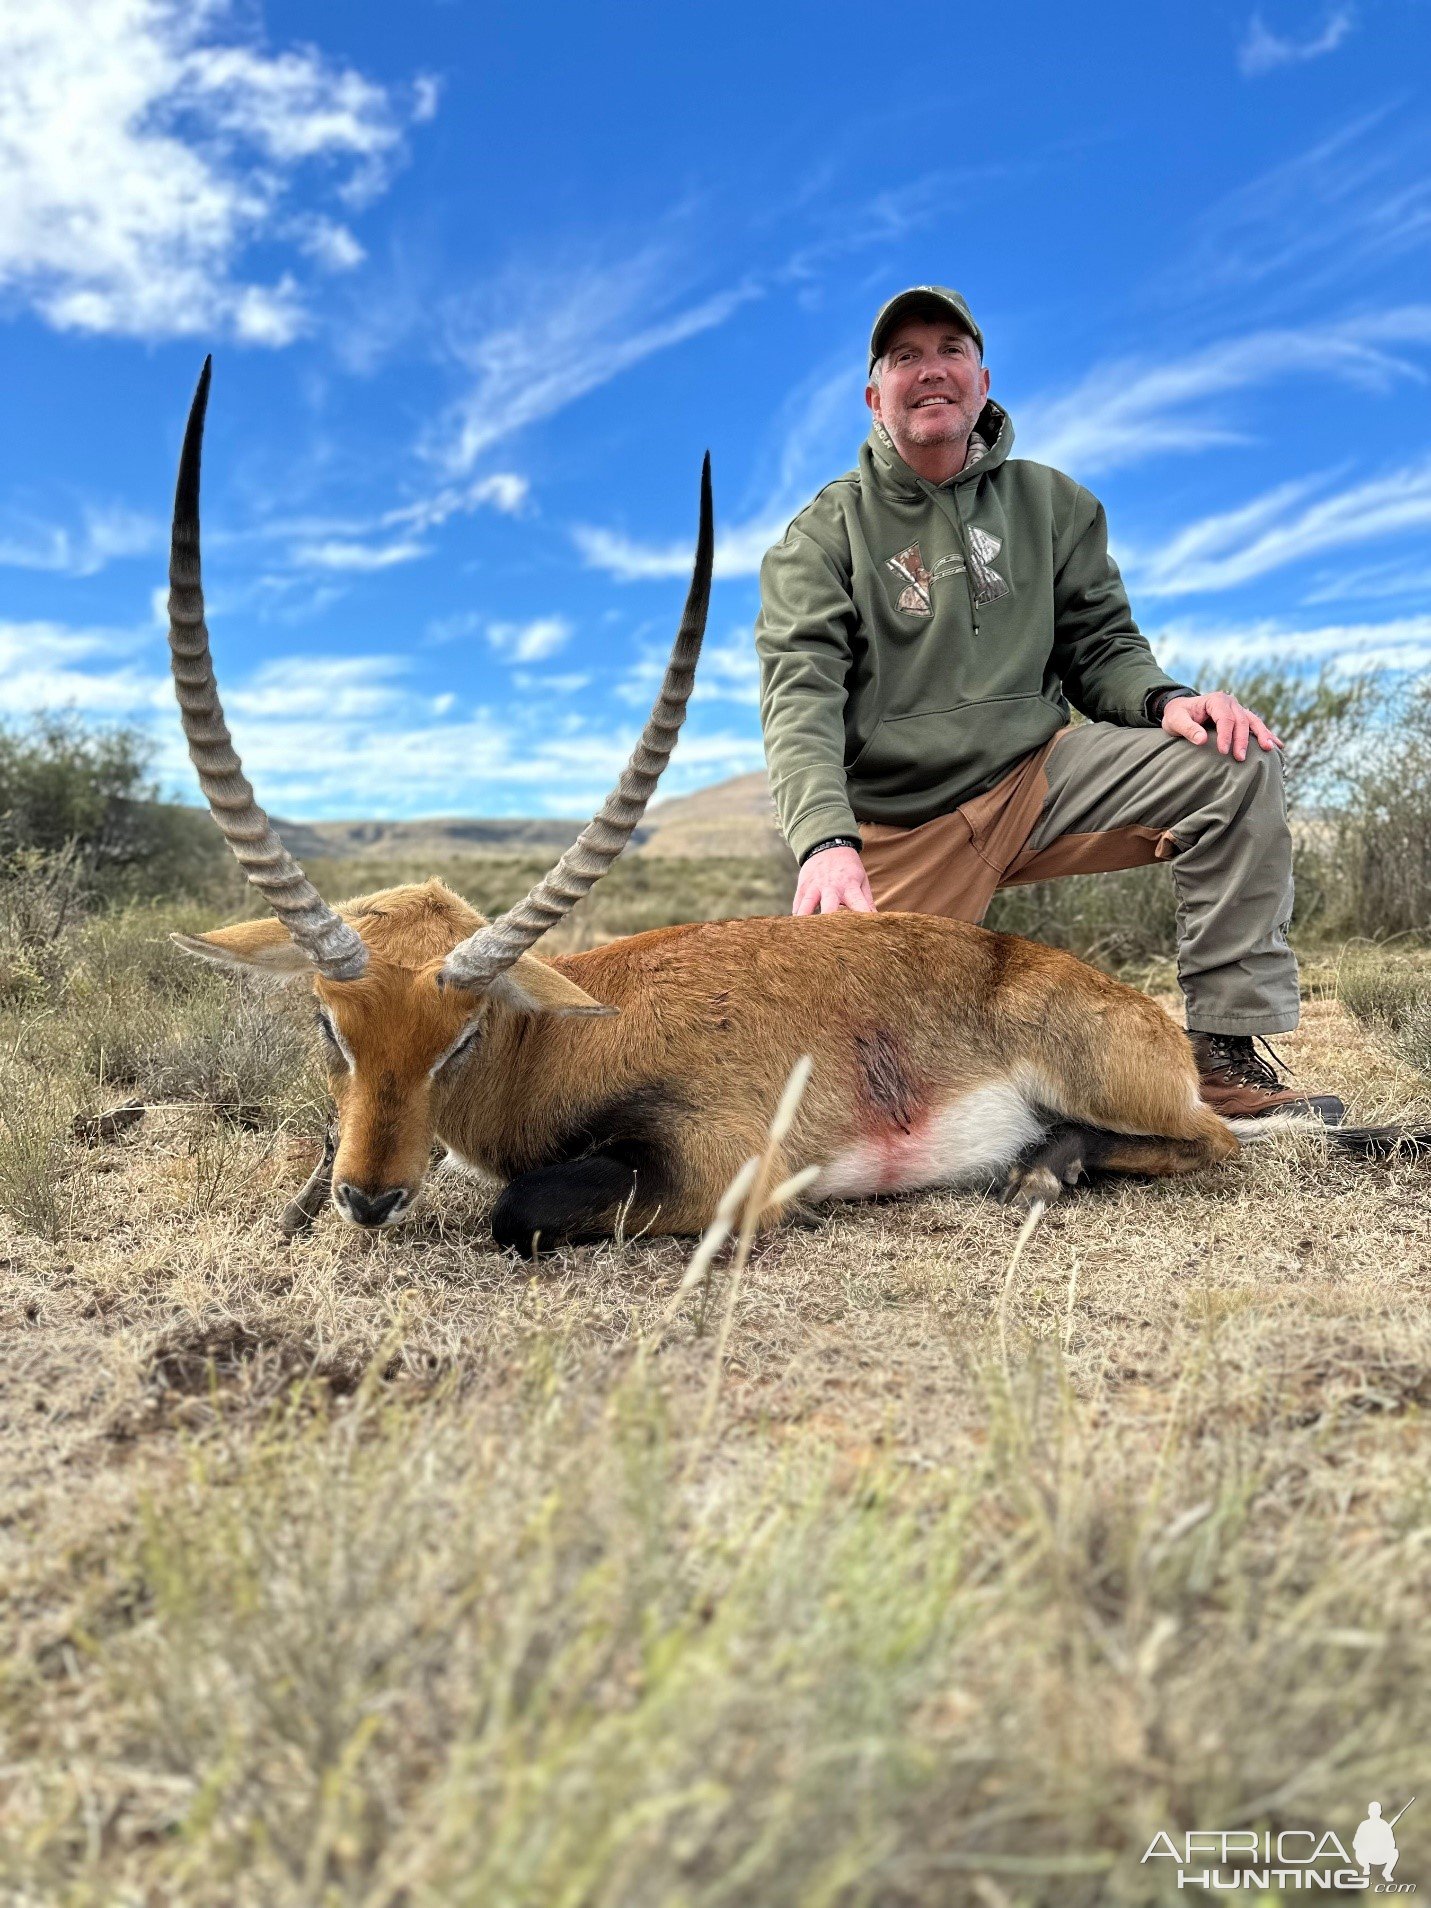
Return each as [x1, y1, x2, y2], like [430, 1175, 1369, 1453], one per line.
[756, 284, 1341, 1120]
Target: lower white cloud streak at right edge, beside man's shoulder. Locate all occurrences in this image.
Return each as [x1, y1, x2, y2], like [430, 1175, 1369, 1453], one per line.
[1122, 458, 1431, 597]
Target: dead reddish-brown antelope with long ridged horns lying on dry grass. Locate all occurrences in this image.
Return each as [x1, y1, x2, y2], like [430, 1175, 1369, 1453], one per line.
[170, 363, 1431, 1252]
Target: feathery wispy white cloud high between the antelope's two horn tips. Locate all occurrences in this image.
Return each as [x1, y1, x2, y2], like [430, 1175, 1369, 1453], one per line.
[429, 246, 756, 475]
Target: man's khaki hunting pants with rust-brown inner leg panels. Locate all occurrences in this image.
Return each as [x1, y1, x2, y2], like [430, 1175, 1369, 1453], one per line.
[861, 723, 1297, 1034]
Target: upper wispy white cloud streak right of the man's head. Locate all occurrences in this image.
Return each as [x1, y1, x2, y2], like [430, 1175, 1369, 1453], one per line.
[1019, 305, 1431, 479]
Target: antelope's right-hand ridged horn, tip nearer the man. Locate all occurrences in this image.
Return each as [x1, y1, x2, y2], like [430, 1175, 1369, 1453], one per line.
[441, 452, 716, 992]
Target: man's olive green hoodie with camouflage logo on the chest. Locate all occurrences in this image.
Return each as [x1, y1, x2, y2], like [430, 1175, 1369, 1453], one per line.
[756, 403, 1179, 857]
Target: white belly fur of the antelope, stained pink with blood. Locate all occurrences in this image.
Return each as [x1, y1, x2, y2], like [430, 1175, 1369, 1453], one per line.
[805, 1080, 1049, 1200]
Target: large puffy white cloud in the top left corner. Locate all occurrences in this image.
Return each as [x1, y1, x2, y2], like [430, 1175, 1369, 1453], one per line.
[0, 0, 424, 345]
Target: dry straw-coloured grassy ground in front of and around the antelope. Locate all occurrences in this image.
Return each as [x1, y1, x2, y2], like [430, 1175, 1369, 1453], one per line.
[0, 870, 1431, 1908]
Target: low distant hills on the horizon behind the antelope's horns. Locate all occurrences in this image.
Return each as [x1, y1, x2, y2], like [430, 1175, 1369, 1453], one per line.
[261, 771, 788, 861]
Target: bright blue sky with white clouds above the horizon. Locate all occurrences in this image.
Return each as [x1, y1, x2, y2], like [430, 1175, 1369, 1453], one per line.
[0, 0, 1431, 817]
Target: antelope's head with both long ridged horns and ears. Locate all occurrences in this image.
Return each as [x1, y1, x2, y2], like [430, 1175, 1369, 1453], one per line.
[170, 359, 714, 1227]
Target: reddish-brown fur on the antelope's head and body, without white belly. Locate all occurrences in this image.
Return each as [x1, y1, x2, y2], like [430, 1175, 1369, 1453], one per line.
[190, 881, 1238, 1233]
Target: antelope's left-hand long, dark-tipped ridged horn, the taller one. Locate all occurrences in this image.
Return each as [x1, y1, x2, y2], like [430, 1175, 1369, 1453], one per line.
[170, 357, 368, 981]
